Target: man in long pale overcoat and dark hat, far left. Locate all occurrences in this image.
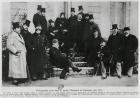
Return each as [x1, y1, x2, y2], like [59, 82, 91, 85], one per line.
[7, 22, 27, 85]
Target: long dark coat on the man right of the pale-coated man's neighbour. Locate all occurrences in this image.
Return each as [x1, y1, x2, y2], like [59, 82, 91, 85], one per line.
[31, 33, 47, 74]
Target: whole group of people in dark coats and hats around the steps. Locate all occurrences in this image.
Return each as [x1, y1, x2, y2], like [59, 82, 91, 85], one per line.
[7, 5, 138, 84]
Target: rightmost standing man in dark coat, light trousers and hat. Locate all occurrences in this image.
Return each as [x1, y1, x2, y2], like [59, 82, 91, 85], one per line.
[123, 27, 138, 77]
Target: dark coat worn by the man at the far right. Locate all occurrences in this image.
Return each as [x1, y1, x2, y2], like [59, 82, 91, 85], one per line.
[123, 34, 138, 67]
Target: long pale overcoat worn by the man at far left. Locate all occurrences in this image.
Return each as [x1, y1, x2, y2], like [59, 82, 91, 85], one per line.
[7, 32, 27, 78]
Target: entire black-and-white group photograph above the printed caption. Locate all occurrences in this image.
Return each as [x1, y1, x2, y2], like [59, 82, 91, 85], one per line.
[1, 0, 139, 93]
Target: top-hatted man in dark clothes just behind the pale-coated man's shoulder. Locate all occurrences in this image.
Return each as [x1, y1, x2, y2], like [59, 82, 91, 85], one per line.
[21, 20, 32, 77]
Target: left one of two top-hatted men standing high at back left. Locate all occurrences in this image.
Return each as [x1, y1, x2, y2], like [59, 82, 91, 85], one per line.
[33, 5, 42, 27]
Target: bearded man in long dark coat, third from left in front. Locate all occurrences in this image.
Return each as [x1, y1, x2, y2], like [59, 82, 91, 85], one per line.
[31, 24, 48, 80]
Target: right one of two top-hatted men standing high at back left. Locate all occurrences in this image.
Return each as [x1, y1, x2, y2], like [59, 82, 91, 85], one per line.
[40, 8, 48, 35]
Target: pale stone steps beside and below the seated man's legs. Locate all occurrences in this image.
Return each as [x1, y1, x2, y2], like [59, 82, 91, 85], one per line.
[53, 56, 94, 77]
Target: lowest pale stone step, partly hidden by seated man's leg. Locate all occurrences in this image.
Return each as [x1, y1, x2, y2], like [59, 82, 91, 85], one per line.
[53, 67, 94, 77]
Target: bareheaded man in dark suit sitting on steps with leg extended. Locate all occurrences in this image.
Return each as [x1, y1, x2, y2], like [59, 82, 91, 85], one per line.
[49, 39, 81, 79]
